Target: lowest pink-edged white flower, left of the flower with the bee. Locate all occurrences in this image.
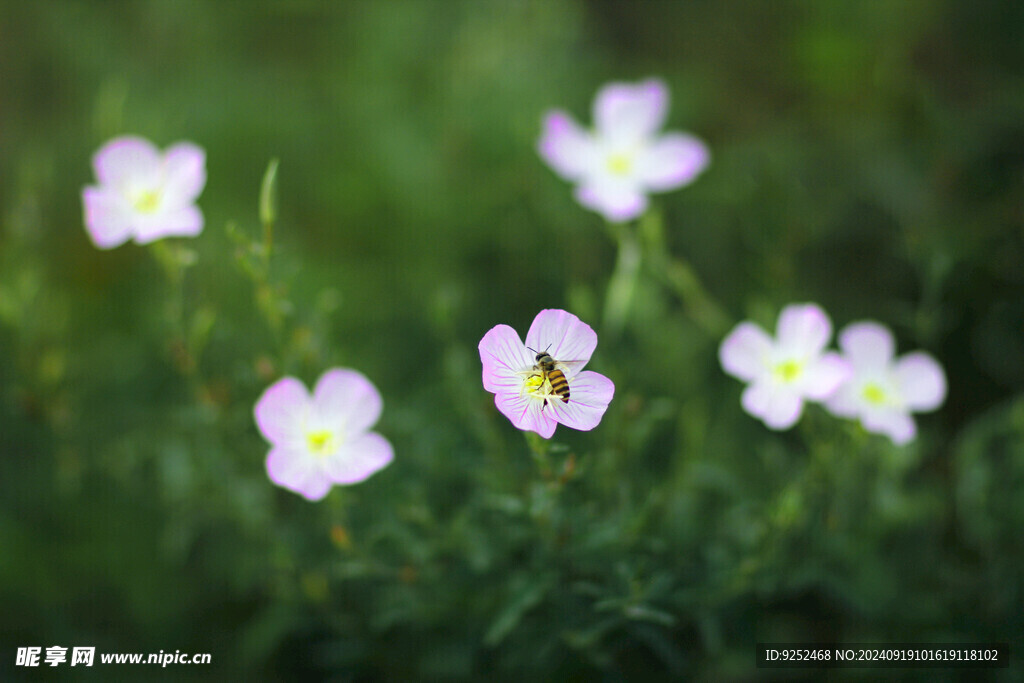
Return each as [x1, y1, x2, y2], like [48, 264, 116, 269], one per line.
[255, 368, 394, 501]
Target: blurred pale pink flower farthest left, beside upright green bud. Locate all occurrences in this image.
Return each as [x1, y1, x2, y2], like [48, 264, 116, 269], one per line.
[82, 135, 206, 249]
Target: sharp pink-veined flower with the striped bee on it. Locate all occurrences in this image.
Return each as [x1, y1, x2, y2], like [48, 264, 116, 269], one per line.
[479, 309, 615, 438]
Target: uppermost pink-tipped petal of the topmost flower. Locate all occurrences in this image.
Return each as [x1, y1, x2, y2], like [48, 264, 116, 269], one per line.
[594, 79, 669, 140]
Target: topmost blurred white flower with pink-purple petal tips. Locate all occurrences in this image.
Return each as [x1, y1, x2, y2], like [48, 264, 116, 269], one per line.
[538, 79, 711, 222]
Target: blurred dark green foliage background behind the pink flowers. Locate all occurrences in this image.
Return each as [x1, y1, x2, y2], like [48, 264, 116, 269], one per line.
[0, 0, 1024, 681]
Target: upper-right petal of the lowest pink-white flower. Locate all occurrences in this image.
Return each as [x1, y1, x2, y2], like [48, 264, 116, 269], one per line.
[308, 368, 384, 439]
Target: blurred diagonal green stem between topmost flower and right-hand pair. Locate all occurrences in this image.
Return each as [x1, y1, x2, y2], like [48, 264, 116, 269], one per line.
[640, 210, 732, 339]
